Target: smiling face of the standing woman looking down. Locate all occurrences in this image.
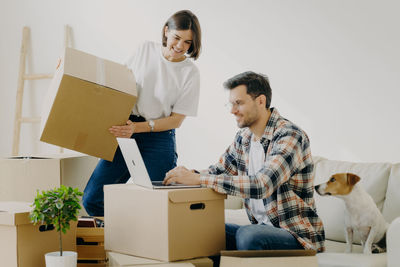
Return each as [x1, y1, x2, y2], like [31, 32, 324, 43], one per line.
[164, 26, 193, 61]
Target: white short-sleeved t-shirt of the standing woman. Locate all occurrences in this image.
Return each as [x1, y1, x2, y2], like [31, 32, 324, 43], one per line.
[126, 41, 200, 120]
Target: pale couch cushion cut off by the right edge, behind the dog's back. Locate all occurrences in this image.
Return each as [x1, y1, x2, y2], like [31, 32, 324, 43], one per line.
[382, 163, 400, 222]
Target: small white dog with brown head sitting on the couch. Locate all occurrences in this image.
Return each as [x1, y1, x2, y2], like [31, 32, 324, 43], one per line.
[315, 173, 389, 254]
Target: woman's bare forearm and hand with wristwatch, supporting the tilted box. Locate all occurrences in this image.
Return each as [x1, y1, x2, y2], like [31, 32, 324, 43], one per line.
[108, 112, 186, 138]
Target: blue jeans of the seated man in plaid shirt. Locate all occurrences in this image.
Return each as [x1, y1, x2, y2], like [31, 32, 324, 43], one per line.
[225, 223, 304, 250]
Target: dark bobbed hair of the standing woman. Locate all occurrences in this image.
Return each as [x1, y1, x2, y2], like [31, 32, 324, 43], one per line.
[162, 10, 201, 60]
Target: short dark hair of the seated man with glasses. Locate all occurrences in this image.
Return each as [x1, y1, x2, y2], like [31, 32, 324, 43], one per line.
[224, 71, 272, 109]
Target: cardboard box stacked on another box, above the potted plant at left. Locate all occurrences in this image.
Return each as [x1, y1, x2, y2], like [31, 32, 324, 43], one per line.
[0, 155, 98, 206]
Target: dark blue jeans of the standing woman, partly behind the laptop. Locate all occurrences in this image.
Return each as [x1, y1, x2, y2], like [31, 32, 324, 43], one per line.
[83, 116, 178, 216]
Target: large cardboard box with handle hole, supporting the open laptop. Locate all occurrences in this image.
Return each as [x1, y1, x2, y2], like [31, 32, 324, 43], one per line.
[104, 184, 226, 261]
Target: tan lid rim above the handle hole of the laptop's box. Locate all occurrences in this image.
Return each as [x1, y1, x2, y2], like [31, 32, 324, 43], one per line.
[168, 188, 226, 203]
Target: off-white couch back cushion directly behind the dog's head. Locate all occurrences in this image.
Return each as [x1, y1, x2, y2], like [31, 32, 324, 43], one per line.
[314, 157, 392, 244]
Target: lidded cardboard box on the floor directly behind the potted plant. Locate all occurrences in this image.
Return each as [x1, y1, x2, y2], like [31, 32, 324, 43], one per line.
[0, 202, 76, 267]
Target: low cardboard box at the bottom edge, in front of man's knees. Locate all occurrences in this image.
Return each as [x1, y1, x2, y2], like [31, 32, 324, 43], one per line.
[219, 250, 318, 267]
